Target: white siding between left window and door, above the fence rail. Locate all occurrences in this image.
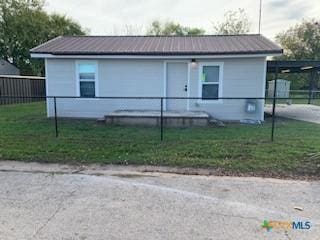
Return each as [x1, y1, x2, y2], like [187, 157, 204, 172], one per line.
[99, 60, 163, 97]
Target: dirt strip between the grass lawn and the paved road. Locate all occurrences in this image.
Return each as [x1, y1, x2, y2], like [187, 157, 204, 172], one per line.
[0, 160, 320, 181]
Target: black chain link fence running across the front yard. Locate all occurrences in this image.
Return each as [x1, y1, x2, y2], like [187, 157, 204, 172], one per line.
[0, 94, 320, 141]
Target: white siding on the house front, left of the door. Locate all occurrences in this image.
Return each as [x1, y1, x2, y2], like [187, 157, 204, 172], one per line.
[47, 59, 164, 118]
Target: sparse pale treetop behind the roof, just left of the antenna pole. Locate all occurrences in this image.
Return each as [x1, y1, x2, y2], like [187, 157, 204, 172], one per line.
[213, 8, 251, 35]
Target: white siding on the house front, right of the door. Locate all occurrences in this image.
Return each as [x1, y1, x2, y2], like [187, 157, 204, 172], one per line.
[190, 58, 266, 120]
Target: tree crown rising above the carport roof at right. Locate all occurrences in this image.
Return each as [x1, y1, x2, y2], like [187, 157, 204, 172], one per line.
[276, 19, 320, 60]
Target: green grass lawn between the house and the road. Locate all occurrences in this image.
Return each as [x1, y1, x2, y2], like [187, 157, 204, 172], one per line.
[0, 103, 320, 176]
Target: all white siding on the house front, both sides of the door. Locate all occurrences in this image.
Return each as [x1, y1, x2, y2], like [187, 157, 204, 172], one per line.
[47, 58, 266, 120]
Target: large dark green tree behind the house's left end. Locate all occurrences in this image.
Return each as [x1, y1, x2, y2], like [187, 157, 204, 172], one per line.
[0, 0, 85, 75]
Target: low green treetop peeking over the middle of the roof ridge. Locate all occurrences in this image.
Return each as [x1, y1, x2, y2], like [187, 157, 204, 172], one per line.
[147, 20, 205, 36]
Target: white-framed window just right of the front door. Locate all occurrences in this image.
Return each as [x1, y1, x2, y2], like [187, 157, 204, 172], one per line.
[200, 64, 221, 100]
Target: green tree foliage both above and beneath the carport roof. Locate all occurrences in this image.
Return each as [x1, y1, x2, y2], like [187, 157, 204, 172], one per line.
[276, 19, 320, 89]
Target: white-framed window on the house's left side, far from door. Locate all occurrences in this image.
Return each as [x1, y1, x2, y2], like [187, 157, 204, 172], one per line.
[77, 62, 97, 98]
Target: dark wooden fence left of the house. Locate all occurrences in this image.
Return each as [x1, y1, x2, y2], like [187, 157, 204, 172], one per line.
[0, 75, 46, 105]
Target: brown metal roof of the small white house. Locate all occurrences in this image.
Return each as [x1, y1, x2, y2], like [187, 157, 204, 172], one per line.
[31, 35, 282, 56]
